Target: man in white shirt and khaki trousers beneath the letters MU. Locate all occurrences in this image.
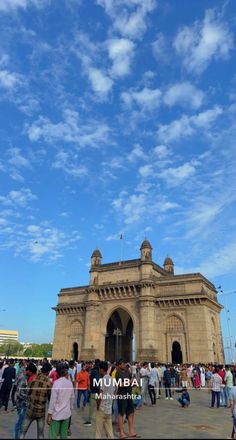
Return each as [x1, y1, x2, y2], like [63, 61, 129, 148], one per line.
[96, 362, 115, 439]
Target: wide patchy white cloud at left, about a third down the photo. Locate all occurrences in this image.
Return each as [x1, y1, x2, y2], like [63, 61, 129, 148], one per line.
[27, 109, 110, 147]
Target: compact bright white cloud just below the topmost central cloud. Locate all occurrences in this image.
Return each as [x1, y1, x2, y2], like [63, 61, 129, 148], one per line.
[107, 38, 135, 77]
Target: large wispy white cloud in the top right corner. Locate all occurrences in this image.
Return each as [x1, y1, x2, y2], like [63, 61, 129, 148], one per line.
[174, 9, 234, 74]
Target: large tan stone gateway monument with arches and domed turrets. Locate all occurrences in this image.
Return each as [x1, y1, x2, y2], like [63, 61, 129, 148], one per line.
[53, 240, 224, 363]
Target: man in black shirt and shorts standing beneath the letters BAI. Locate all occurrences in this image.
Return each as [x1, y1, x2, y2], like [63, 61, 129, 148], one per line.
[116, 359, 137, 438]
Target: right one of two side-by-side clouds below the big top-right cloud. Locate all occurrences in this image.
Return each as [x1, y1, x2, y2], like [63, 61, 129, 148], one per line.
[163, 82, 204, 109]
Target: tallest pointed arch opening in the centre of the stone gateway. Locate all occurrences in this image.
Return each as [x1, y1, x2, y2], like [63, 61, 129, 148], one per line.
[105, 308, 133, 362]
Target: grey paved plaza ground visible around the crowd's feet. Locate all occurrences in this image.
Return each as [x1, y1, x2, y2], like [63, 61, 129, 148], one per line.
[0, 390, 232, 439]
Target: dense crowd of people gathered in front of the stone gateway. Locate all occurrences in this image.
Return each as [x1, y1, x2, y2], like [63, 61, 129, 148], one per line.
[0, 358, 236, 439]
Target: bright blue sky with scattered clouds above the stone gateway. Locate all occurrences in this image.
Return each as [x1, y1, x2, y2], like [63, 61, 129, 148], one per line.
[0, 0, 236, 360]
